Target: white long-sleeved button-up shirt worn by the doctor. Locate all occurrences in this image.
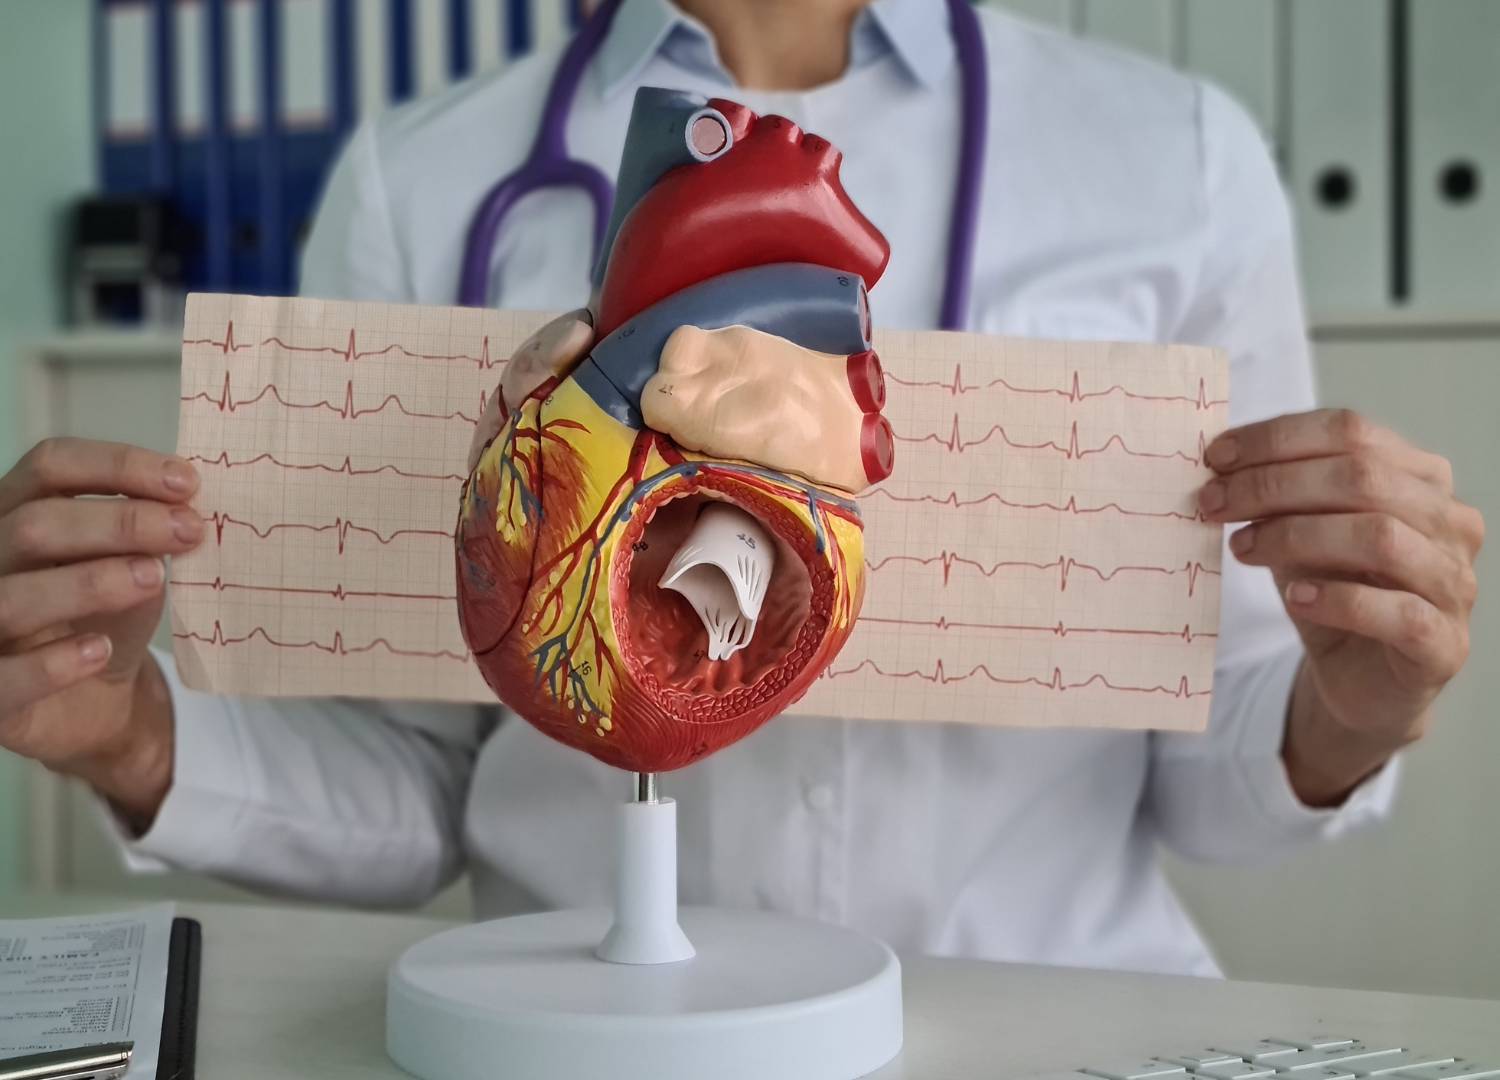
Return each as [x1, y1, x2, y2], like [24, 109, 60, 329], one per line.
[134, 0, 1395, 974]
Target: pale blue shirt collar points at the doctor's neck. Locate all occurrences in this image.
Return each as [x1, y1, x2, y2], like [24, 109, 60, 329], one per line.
[596, 0, 954, 99]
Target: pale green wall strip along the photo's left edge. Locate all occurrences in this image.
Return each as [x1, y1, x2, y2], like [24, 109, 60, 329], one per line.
[0, 0, 93, 891]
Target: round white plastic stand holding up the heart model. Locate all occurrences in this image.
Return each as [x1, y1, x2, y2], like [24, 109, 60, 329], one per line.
[386, 800, 902, 1080]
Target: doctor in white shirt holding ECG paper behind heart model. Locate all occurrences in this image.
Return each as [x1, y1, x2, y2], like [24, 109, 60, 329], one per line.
[0, 0, 1482, 974]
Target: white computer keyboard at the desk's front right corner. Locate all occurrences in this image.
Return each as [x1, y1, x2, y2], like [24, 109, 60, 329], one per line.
[1031, 1035, 1500, 1080]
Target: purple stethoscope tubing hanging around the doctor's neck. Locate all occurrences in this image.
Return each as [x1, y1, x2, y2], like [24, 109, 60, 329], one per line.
[459, 0, 989, 330]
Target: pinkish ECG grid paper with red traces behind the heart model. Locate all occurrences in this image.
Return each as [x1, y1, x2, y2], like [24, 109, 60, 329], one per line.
[171, 296, 1229, 731]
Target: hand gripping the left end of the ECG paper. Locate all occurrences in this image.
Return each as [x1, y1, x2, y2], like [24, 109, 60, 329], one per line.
[0, 438, 204, 830]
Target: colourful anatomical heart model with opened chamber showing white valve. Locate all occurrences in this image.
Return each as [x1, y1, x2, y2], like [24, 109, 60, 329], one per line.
[456, 90, 894, 773]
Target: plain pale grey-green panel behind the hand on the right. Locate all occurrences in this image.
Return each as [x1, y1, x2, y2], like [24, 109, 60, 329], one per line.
[1173, 333, 1500, 998]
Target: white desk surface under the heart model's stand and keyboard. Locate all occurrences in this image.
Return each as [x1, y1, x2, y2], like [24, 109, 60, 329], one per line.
[0, 896, 1500, 1080]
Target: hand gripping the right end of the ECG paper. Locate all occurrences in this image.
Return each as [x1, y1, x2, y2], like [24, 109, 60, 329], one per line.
[1200, 410, 1485, 801]
